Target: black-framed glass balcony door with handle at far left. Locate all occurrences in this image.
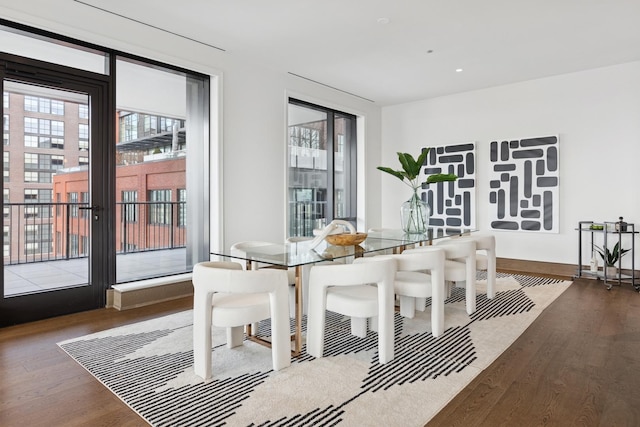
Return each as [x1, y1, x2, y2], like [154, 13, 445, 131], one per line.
[0, 54, 114, 326]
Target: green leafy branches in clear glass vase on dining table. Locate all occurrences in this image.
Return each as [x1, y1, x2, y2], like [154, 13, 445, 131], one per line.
[378, 148, 458, 234]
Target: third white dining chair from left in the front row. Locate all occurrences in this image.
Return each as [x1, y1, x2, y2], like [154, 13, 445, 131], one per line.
[358, 246, 445, 337]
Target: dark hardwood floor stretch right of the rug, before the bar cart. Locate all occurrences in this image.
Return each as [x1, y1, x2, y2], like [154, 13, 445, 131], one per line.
[427, 279, 640, 427]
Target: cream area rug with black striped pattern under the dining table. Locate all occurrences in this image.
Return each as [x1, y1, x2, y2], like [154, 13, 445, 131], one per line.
[59, 274, 571, 426]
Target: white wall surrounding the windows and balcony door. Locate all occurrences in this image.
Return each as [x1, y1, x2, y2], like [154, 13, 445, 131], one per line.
[0, 0, 381, 254]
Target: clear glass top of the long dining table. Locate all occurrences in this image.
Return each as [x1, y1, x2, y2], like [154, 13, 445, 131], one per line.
[211, 227, 474, 267]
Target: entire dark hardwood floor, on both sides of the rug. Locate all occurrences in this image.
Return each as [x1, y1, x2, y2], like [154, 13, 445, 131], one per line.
[0, 279, 640, 427]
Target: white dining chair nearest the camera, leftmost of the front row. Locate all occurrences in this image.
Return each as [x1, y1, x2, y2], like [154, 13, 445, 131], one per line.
[192, 261, 291, 381]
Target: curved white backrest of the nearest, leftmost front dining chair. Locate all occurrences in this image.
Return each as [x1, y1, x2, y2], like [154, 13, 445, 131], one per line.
[192, 261, 289, 298]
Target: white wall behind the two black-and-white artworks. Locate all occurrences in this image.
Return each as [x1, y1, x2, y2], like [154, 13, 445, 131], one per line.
[382, 62, 640, 266]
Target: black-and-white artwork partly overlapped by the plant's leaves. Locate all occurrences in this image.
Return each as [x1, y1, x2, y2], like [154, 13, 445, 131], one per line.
[423, 142, 476, 228]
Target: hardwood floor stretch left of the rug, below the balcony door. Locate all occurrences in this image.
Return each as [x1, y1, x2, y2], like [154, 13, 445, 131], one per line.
[0, 298, 193, 427]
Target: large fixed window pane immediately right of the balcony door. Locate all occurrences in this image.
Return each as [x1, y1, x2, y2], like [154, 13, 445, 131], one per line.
[113, 57, 208, 282]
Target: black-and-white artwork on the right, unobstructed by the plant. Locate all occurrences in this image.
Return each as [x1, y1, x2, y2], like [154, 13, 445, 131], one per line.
[489, 136, 560, 233]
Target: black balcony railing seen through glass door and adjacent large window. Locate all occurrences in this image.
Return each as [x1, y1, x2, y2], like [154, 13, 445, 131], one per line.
[3, 202, 186, 265]
